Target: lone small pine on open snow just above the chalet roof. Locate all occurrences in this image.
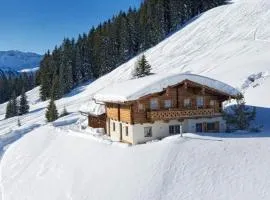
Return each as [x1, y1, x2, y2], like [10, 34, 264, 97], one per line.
[133, 55, 152, 78]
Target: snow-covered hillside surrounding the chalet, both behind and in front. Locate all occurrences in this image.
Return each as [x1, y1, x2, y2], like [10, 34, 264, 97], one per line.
[0, 0, 270, 200]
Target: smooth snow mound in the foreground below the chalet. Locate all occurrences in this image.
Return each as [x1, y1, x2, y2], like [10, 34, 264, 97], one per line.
[1, 126, 270, 200]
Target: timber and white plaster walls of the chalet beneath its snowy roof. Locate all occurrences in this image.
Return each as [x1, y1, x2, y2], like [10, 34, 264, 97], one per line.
[89, 74, 239, 144]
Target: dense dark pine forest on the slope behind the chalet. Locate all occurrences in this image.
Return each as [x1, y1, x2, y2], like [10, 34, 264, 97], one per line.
[37, 0, 227, 102]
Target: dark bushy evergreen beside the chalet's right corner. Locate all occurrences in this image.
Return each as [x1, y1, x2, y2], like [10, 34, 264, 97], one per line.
[224, 95, 256, 130]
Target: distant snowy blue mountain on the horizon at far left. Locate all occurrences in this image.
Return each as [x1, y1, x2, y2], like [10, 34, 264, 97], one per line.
[0, 50, 43, 72]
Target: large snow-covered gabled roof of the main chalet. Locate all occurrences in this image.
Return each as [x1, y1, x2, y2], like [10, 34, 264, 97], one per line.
[94, 74, 240, 102]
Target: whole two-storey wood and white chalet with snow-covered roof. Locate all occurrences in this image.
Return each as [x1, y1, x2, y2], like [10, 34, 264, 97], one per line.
[83, 74, 239, 144]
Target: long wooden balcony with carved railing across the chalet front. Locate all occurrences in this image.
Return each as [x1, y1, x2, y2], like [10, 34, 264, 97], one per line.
[147, 108, 221, 121]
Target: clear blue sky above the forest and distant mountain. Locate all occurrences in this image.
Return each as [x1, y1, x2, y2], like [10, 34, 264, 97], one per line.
[0, 0, 141, 54]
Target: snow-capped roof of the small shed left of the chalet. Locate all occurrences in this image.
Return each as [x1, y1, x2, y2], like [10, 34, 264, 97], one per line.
[80, 100, 105, 116]
